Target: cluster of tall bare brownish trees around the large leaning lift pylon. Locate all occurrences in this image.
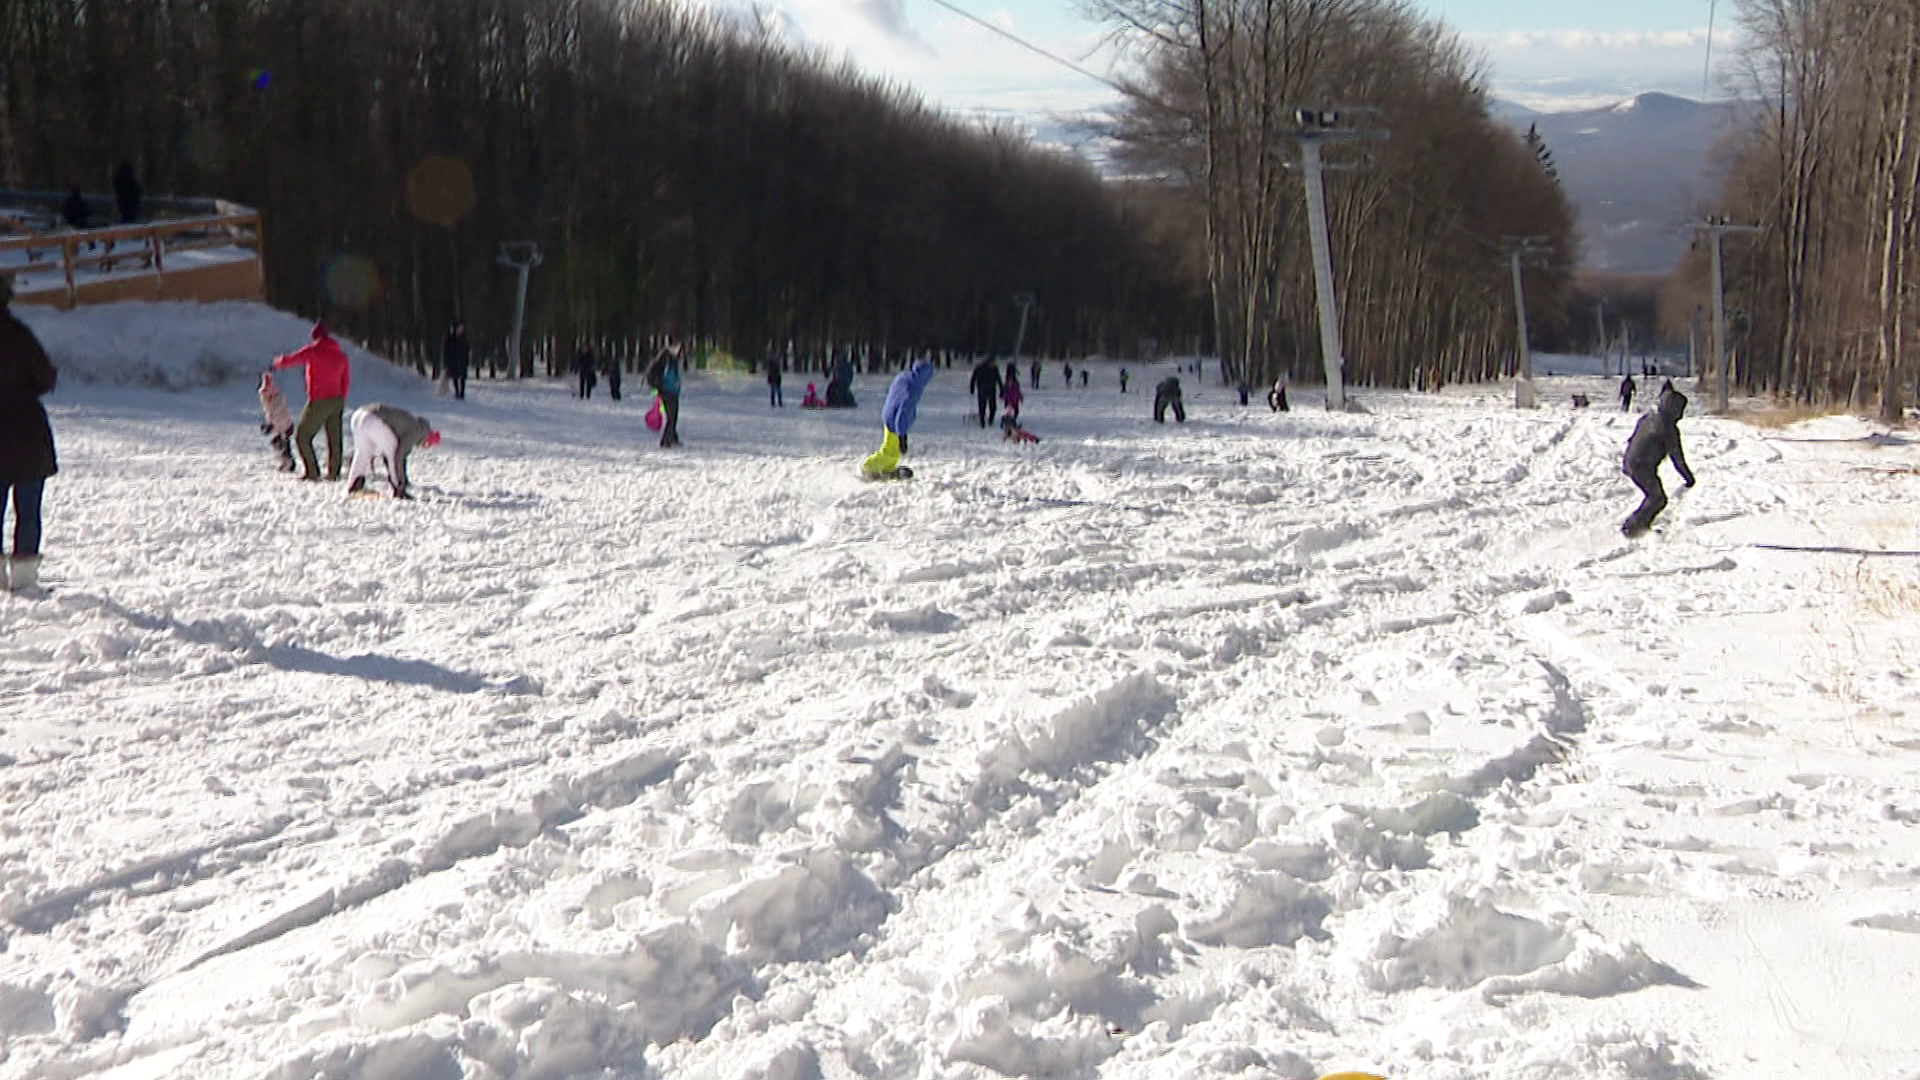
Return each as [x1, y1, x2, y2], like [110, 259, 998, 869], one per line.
[1092, 0, 1578, 386]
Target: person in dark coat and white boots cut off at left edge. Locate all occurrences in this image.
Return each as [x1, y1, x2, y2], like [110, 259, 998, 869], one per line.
[0, 275, 60, 592]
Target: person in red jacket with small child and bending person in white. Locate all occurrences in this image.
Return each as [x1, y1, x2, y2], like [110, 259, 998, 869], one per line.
[259, 323, 440, 500]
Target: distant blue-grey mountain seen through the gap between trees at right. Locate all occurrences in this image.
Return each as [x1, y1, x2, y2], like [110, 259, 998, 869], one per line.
[1496, 94, 1747, 273]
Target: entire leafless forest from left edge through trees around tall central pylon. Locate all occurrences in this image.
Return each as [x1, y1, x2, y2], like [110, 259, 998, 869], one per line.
[0, 0, 1578, 384]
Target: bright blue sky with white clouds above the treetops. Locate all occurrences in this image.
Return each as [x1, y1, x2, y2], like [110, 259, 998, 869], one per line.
[721, 0, 1732, 121]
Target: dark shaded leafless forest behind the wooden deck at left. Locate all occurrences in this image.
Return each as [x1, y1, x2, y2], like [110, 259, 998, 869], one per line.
[0, 0, 1208, 357]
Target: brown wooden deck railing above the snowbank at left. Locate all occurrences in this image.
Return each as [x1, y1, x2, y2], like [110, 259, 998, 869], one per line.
[0, 202, 267, 307]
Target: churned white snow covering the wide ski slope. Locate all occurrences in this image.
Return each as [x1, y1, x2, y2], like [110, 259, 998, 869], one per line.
[0, 297, 1920, 1080]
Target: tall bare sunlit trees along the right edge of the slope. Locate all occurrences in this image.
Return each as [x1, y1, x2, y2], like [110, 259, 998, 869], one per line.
[1697, 0, 1920, 421]
